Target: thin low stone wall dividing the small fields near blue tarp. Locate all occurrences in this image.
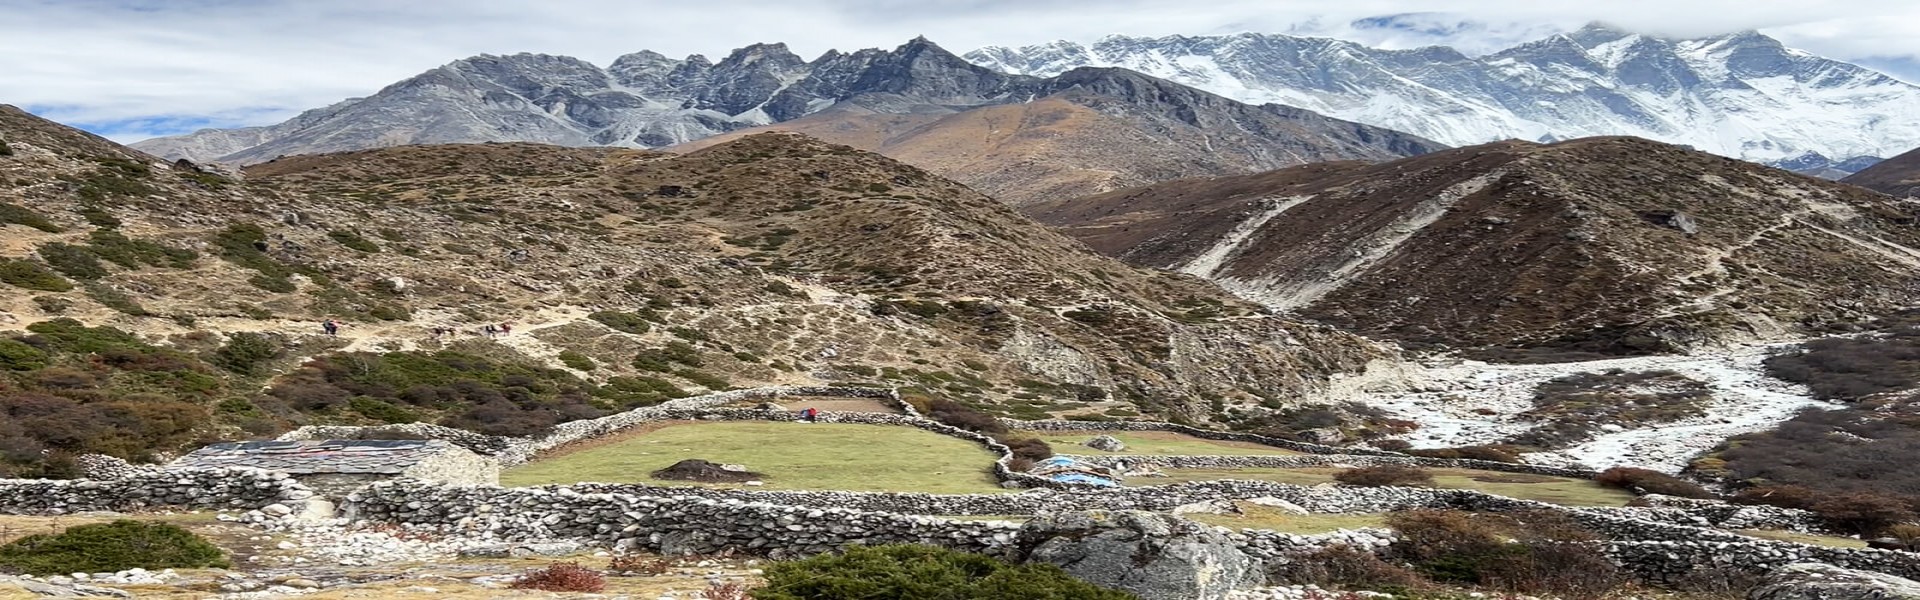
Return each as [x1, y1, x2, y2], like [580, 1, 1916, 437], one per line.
[1068, 454, 1594, 479]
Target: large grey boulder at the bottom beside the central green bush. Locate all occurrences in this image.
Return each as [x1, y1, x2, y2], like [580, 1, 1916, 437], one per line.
[1014, 510, 1263, 600]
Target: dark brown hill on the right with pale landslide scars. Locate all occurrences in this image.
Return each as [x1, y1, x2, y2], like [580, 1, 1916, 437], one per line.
[1031, 138, 1920, 354]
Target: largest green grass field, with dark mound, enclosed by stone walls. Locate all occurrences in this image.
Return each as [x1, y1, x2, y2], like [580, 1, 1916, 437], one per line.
[499, 421, 1004, 494]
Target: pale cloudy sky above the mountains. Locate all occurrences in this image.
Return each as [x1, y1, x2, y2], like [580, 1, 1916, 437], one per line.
[11, 0, 1920, 142]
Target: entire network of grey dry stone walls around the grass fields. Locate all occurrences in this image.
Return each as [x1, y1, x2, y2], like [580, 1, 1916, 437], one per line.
[0, 387, 1920, 592]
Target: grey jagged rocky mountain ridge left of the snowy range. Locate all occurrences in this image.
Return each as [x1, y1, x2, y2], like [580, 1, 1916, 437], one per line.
[134, 38, 1440, 185]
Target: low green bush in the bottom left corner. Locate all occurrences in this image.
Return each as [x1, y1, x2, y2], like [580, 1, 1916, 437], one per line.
[0, 519, 228, 575]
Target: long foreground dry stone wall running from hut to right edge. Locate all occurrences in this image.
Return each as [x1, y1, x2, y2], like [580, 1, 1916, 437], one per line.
[344, 481, 1920, 579]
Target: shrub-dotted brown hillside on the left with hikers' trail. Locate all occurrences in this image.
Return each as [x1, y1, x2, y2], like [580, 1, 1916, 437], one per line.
[0, 108, 1384, 473]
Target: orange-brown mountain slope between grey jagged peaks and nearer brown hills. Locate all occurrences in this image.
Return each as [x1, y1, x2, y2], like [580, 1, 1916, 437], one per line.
[676, 69, 1444, 206]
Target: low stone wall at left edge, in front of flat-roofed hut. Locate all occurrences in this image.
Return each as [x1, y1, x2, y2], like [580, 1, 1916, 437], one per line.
[0, 467, 313, 515]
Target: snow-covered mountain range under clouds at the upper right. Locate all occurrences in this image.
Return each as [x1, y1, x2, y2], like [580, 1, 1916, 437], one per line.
[966, 25, 1920, 175]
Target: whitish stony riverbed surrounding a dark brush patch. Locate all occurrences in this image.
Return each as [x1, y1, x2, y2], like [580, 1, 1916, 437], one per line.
[1359, 344, 1834, 473]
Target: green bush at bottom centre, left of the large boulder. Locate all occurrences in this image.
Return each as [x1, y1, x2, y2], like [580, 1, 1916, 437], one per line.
[751, 546, 1137, 600]
